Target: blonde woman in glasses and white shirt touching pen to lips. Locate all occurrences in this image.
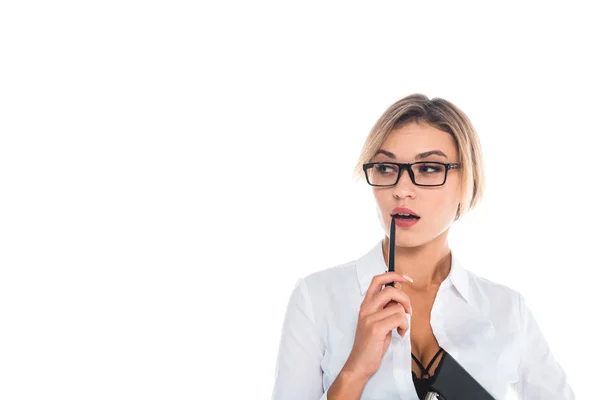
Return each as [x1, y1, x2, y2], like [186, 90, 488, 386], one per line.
[272, 95, 574, 400]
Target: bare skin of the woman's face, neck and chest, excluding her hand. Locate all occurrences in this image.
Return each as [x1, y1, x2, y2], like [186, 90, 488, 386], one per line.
[372, 123, 461, 377]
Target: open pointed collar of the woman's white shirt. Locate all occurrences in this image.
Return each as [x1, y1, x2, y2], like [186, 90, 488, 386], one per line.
[356, 240, 470, 302]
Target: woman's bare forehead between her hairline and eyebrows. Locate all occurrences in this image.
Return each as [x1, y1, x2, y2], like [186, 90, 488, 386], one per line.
[381, 123, 458, 159]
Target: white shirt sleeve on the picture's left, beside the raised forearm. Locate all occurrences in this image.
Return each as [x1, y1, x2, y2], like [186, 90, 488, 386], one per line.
[271, 279, 327, 400]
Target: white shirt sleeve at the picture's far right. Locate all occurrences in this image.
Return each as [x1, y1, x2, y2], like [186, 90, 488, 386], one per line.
[513, 294, 575, 400]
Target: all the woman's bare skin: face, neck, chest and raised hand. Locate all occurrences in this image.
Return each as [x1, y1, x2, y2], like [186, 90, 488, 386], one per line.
[328, 123, 461, 399]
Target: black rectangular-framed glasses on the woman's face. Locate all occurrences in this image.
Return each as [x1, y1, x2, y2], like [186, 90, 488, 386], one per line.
[363, 161, 461, 186]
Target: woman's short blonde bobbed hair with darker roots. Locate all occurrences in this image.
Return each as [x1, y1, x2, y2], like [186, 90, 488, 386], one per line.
[354, 94, 485, 219]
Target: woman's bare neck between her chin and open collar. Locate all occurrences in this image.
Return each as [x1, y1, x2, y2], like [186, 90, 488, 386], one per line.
[383, 231, 452, 291]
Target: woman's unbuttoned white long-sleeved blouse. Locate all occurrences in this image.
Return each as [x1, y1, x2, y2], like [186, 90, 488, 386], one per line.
[272, 241, 574, 400]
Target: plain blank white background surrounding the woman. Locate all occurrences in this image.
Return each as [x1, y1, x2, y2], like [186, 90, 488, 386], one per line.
[0, 1, 600, 399]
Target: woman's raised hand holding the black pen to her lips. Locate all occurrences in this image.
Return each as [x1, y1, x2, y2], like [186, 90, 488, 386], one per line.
[344, 272, 412, 379]
